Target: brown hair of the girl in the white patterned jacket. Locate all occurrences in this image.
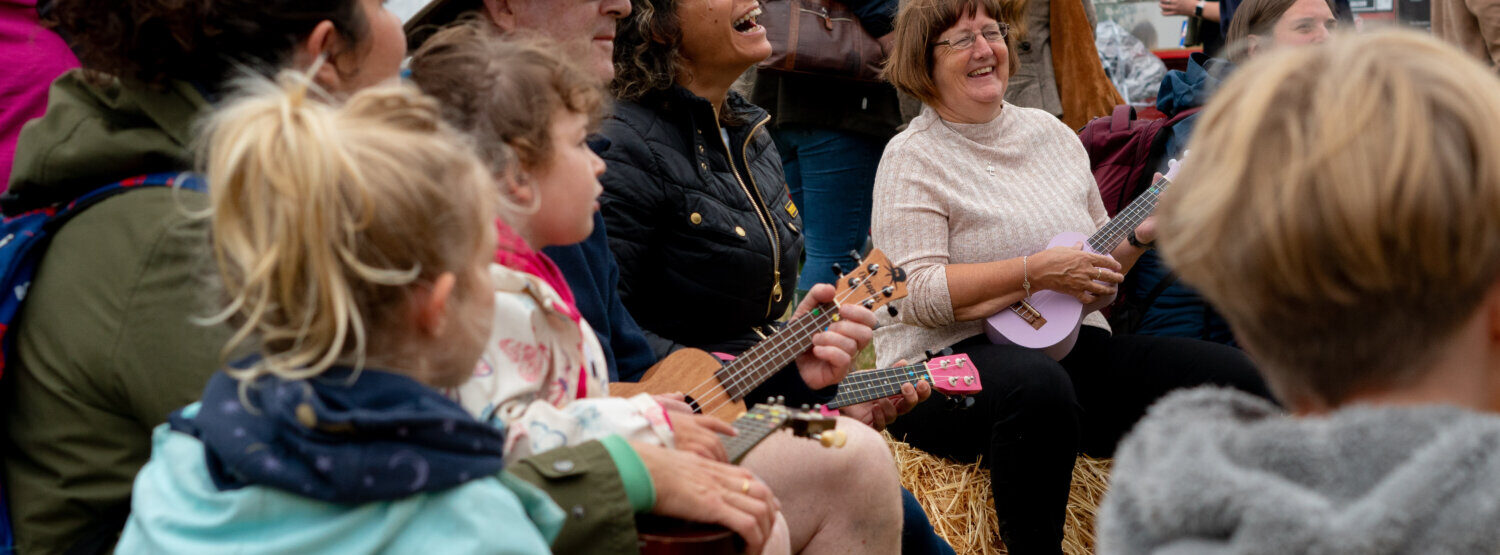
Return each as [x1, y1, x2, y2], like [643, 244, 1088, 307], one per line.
[410, 17, 608, 176]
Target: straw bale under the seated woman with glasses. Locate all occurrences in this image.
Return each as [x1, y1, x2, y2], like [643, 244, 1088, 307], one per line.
[885, 434, 1110, 555]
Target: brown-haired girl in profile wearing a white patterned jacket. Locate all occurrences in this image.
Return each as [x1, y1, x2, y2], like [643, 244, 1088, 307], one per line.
[411, 21, 732, 459]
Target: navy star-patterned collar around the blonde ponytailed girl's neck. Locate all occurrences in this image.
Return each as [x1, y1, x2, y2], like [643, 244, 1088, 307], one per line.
[168, 359, 506, 504]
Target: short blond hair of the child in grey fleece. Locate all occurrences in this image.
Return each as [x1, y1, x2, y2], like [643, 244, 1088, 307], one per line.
[1161, 30, 1500, 405]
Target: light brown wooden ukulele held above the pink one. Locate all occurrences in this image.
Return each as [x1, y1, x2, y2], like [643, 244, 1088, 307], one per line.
[609, 251, 906, 422]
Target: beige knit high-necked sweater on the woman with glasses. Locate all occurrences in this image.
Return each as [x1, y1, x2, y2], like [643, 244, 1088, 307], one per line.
[872, 104, 1109, 366]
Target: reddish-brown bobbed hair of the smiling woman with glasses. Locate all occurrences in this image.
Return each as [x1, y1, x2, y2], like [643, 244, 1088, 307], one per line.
[885, 0, 1043, 105]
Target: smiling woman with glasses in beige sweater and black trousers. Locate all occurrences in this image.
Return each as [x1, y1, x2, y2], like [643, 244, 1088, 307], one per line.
[873, 0, 1269, 554]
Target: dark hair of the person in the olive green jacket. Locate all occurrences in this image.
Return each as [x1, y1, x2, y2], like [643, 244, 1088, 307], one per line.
[47, 0, 369, 92]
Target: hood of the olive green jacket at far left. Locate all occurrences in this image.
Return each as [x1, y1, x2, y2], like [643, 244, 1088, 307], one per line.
[0, 69, 209, 215]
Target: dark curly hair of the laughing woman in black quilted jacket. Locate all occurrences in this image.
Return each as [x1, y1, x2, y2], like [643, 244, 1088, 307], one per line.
[609, 0, 687, 101]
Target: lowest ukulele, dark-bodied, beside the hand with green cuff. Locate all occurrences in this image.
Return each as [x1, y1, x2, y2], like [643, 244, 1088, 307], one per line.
[636, 399, 846, 555]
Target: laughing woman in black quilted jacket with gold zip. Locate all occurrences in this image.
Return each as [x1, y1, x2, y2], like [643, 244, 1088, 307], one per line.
[600, 0, 902, 554]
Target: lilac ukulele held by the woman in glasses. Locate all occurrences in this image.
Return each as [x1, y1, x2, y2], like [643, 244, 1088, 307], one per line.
[984, 161, 1178, 360]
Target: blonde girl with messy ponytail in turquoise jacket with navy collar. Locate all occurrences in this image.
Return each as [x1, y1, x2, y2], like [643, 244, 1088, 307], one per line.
[119, 75, 561, 554]
